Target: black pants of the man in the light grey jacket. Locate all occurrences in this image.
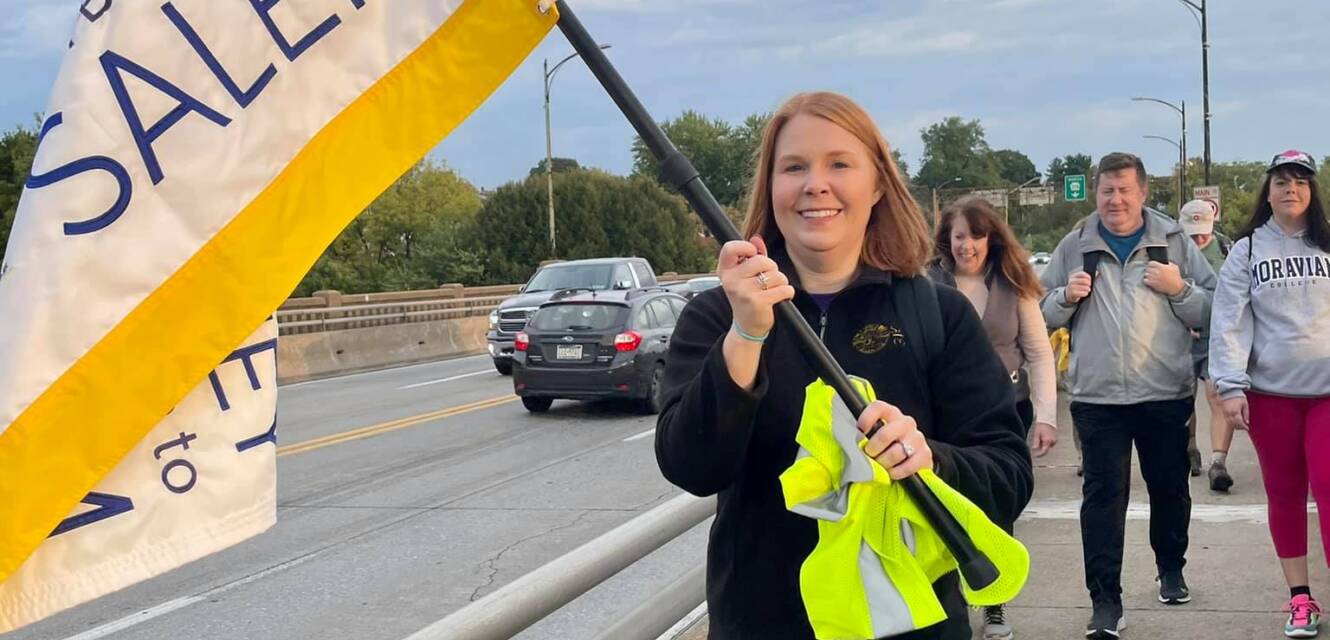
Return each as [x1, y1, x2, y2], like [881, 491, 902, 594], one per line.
[1072, 398, 1193, 603]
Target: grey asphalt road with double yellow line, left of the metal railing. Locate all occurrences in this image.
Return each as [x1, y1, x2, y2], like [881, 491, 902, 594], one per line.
[4, 357, 706, 640]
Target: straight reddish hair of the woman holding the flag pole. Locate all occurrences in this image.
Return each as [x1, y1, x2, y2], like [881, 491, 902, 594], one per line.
[743, 92, 931, 275]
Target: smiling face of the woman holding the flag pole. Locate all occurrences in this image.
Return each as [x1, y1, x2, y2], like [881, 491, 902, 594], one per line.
[771, 114, 882, 255]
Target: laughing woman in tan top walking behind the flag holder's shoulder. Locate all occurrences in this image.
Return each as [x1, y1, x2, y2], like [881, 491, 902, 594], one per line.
[928, 197, 1057, 640]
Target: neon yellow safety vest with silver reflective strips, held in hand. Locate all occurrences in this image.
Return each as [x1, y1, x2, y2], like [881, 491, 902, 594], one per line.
[781, 378, 1029, 640]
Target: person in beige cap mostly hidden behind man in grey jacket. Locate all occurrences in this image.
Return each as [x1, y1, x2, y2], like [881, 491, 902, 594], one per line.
[1178, 200, 1233, 492]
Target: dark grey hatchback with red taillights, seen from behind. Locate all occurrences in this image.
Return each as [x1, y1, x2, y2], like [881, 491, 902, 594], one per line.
[512, 287, 686, 414]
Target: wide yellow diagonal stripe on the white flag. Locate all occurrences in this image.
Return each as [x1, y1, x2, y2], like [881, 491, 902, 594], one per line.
[0, 0, 557, 581]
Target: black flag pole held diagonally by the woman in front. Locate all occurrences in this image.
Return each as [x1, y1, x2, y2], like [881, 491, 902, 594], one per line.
[555, 0, 998, 589]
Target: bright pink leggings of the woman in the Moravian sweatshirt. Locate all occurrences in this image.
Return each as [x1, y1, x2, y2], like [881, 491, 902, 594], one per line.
[1248, 391, 1330, 558]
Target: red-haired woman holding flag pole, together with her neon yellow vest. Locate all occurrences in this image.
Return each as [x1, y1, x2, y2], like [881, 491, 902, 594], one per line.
[656, 93, 1032, 639]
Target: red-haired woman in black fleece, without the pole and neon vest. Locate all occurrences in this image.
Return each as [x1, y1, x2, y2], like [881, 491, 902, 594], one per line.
[656, 93, 1032, 640]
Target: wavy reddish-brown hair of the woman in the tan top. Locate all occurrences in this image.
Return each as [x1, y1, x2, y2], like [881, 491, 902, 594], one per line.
[935, 196, 1044, 299]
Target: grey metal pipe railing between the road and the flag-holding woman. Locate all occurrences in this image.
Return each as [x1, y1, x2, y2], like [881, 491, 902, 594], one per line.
[406, 494, 716, 640]
